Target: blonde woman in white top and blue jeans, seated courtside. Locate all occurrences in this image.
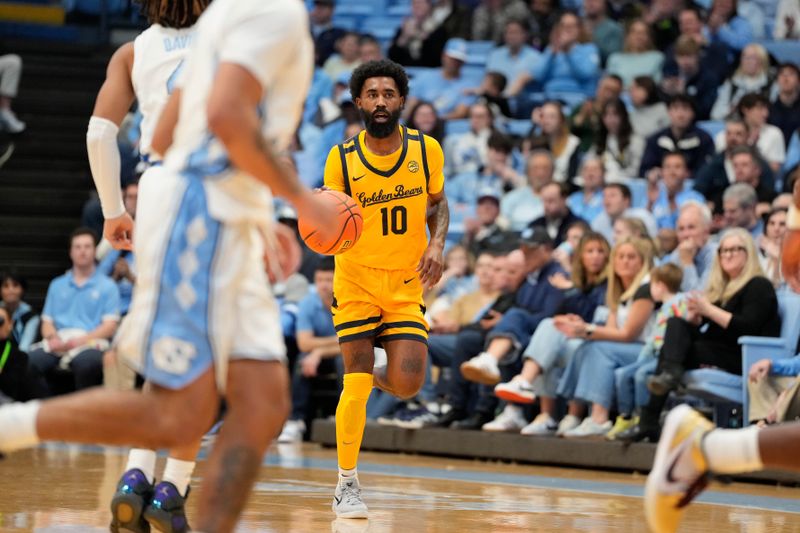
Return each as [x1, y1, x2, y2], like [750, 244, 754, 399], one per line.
[555, 238, 655, 437]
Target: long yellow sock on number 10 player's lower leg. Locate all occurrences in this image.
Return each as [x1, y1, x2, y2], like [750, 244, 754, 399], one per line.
[336, 373, 372, 470]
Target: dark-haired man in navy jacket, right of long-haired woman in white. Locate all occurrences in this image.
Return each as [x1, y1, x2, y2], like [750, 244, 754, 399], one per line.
[639, 94, 714, 177]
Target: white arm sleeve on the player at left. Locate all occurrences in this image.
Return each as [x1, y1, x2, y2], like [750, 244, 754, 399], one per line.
[86, 116, 125, 220]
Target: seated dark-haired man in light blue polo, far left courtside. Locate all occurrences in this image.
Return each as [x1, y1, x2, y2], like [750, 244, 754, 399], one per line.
[29, 228, 120, 390]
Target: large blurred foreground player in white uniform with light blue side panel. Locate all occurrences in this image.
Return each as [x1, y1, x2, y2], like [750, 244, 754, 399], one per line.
[0, 0, 332, 533]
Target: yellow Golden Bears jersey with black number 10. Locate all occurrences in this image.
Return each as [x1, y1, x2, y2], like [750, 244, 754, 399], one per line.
[325, 126, 444, 270]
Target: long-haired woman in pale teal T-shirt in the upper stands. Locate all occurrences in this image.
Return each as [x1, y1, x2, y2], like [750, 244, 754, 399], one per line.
[606, 19, 664, 87]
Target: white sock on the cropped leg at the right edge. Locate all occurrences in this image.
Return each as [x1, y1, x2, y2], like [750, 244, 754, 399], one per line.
[702, 426, 764, 474]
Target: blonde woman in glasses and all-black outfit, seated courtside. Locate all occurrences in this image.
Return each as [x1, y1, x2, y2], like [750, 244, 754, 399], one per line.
[617, 228, 781, 442]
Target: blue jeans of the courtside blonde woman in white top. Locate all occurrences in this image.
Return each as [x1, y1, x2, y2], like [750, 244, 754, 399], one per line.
[573, 341, 642, 409]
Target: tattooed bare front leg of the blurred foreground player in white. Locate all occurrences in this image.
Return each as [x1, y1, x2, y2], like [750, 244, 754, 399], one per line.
[194, 359, 291, 533]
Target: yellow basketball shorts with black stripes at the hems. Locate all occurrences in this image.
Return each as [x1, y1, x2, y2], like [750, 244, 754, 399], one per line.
[331, 260, 428, 345]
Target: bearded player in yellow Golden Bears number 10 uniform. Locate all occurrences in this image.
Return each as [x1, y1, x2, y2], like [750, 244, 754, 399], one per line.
[325, 60, 449, 518]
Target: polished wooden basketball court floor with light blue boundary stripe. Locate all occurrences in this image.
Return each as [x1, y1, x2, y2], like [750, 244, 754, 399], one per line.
[0, 444, 800, 533]
